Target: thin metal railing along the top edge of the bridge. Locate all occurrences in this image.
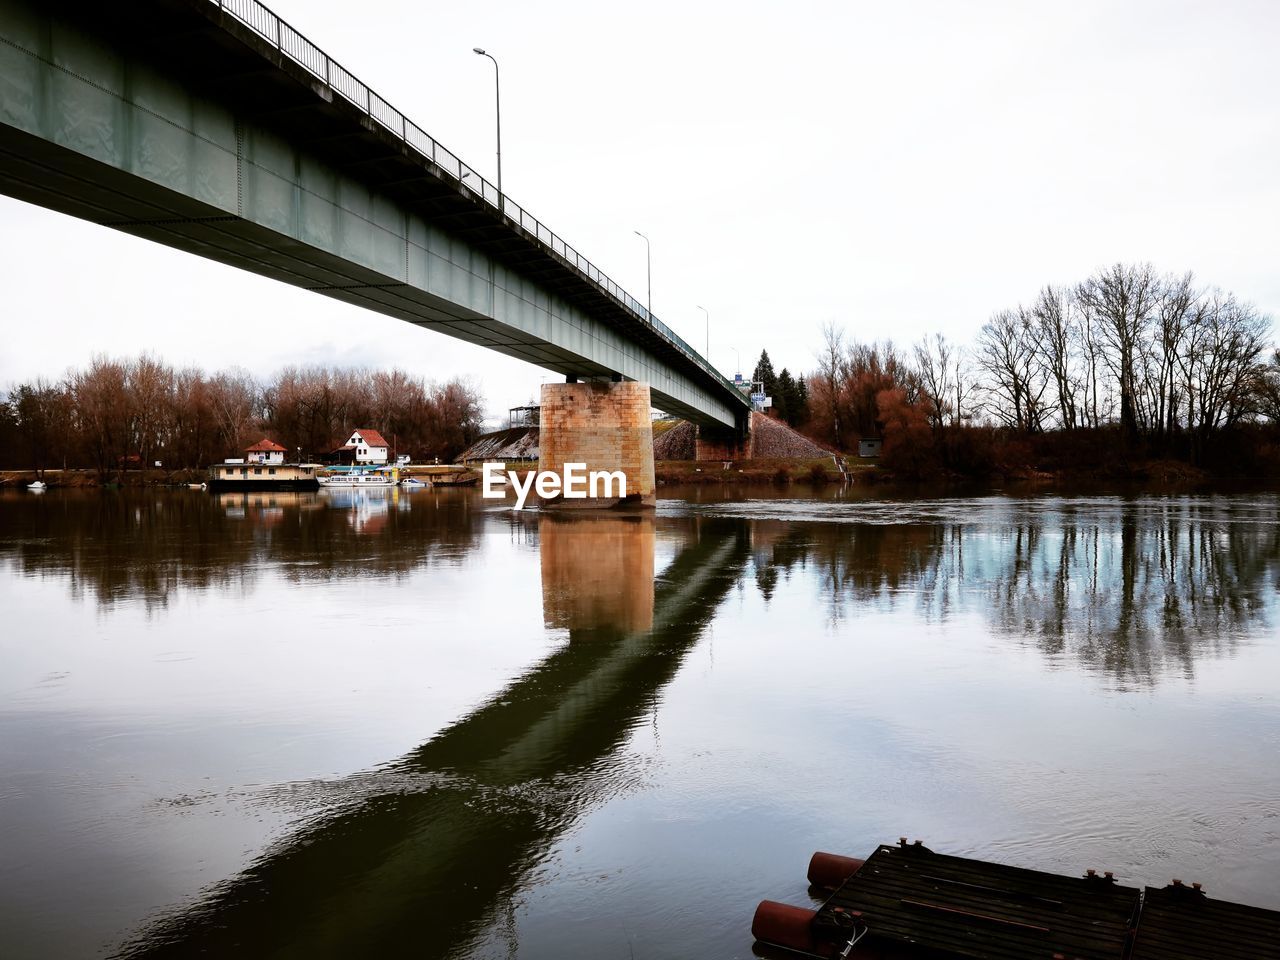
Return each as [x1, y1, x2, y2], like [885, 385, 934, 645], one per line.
[210, 0, 745, 402]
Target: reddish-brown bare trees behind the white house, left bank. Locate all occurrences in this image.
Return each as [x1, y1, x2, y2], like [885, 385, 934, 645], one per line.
[0, 355, 483, 477]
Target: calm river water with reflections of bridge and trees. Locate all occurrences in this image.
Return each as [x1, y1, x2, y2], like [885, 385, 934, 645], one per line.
[0, 489, 1280, 960]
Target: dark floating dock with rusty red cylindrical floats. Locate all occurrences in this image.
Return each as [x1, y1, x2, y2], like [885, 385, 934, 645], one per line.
[751, 840, 1280, 960]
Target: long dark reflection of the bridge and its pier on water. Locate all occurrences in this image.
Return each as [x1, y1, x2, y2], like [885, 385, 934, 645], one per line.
[123, 517, 749, 956]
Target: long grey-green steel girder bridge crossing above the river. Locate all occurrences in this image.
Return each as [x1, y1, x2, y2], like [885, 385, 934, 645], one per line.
[0, 0, 750, 496]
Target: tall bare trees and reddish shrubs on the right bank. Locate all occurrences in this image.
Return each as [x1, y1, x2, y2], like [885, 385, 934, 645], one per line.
[805, 264, 1280, 470]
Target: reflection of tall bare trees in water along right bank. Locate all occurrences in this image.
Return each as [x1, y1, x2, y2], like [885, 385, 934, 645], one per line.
[753, 499, 1280, 681]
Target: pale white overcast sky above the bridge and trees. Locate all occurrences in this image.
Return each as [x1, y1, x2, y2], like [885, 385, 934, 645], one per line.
[0, 0, 1280, 412]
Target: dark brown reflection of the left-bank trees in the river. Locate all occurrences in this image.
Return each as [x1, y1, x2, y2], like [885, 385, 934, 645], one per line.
[0, 490, 480, 607]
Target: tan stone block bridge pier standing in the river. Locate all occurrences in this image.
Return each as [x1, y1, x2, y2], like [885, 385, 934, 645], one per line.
[538, 380, 657, 509]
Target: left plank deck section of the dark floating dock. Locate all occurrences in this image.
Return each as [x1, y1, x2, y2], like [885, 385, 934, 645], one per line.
[814, 845, 1136, 960]
